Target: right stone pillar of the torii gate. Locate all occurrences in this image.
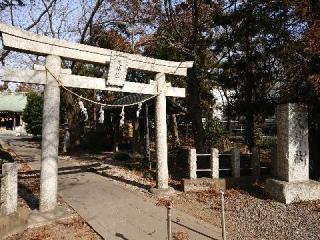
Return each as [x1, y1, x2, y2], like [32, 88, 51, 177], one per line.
[156, 73, 169, 189]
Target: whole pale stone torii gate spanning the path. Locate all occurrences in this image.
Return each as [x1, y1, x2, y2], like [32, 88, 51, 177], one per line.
[0, 23, 193, 212]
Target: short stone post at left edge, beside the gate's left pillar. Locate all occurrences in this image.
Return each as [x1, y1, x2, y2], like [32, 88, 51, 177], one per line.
[0, 163, 18, 215]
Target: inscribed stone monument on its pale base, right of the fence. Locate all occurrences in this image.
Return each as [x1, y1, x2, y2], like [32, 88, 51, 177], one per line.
[266, 103, 320, 204]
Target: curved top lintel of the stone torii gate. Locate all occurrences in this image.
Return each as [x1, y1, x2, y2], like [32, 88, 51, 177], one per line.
[0, 23, 193, 76]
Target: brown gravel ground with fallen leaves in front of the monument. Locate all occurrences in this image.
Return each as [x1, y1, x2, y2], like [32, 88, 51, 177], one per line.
[171, 190, 320, 240]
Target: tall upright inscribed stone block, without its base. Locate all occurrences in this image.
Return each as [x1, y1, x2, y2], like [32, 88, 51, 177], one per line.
[275, 103, 309, 182]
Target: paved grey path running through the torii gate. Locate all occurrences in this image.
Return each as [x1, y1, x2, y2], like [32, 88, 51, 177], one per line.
[1, 139, 221, 240]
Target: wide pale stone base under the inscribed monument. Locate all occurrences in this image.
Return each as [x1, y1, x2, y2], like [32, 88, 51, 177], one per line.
[265, 178, 320, 204]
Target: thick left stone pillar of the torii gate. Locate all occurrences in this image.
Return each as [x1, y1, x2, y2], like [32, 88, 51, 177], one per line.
[40, 55, 61, 212]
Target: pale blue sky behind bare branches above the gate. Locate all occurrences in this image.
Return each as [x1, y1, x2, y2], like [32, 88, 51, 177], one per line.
[0, 0, 95, 90]
